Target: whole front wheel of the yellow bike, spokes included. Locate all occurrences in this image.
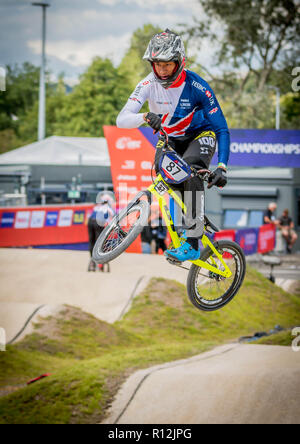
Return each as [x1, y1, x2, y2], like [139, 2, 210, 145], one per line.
[93, 200, 150, 264]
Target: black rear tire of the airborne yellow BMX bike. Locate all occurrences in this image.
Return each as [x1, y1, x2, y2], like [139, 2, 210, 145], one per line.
[187, 240, 246, 311]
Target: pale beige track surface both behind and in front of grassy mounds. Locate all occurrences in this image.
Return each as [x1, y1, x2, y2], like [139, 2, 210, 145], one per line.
[0, 249, 300, 424]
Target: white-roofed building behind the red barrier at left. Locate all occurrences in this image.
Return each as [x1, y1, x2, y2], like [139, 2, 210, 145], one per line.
[0, 136, 112, 206]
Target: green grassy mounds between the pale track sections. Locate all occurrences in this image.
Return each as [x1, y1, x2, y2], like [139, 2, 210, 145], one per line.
[0, 268, 300, 424]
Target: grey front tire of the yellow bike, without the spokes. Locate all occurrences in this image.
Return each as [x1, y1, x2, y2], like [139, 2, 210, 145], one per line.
[93, 200, 150, 264]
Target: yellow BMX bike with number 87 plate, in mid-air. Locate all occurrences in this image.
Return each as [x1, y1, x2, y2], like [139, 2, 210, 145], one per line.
[93, 129, 246, 311]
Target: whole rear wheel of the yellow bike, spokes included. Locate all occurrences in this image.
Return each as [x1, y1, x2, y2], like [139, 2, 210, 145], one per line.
[187, 240, 246, 311]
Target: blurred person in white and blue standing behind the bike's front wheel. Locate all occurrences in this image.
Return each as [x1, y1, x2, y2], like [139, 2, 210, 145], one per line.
[88, 195, 114, 271]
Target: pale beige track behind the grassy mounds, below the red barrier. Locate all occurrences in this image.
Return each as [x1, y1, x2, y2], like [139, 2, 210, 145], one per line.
[0, 249, 187, 342]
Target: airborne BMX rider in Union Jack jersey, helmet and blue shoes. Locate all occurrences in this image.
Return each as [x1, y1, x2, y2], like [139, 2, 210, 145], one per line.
[117, 29, 230, 262]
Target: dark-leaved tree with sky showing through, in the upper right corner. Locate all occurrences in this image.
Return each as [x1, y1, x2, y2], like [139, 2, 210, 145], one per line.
[187, 0, 300, 93]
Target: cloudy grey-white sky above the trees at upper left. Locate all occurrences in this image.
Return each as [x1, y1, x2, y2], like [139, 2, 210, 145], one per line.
[0, 0, 209, 86]
